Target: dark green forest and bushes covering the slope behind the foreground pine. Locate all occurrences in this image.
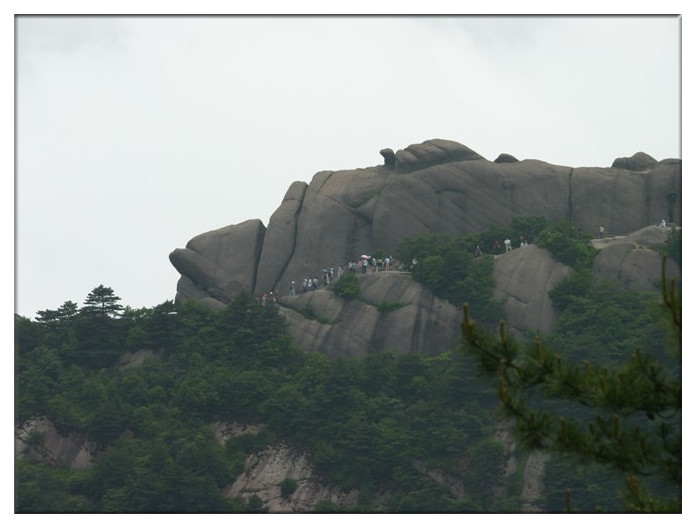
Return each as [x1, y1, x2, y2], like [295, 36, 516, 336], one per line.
[15, 222, 681, 513]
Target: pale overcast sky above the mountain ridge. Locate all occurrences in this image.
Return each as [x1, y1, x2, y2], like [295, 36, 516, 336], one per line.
[15, 16, 682, 317]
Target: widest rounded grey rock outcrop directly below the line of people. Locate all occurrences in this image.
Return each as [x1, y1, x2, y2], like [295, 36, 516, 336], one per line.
[280, 272, 461, 358]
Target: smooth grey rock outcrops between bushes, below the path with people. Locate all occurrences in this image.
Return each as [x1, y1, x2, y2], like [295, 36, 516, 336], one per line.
[279, 226, 681, 350]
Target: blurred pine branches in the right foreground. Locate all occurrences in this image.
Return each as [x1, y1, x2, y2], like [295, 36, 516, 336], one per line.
[462, 255, 682, 512]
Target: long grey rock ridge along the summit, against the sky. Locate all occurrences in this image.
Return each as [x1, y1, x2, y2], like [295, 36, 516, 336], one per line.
[170, 139, 681, 314]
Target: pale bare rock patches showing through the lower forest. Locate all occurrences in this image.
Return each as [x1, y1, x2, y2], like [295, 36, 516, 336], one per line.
[15, 417, 546, 513]
